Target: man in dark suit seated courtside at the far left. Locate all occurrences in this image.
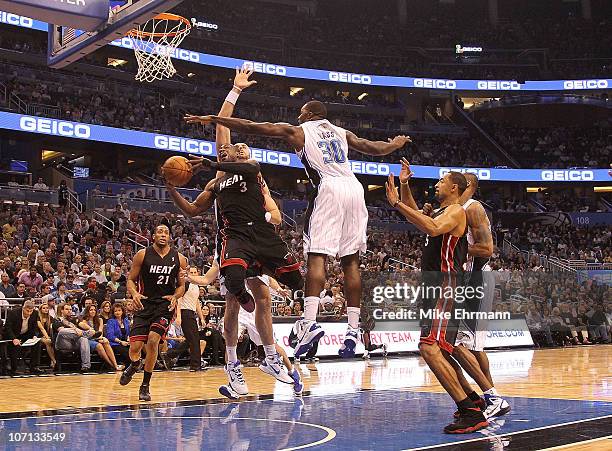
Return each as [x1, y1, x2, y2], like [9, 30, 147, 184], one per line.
[5, 301, 42, 376]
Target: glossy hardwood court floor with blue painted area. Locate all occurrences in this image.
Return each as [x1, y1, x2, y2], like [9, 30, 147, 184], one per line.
[0, 345, 612, 450]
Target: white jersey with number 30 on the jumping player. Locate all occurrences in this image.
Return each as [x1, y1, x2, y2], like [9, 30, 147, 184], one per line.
[297, 119, 355, 186]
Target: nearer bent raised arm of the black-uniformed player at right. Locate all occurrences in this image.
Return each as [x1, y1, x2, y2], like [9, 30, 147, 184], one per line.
[385, 174, 465, 236]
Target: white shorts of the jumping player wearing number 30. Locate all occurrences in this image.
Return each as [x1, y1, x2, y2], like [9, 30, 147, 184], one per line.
[304, 177, 368, 257]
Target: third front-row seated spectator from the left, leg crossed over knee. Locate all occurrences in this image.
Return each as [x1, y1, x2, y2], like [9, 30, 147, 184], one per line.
[53, 303, 95, 372]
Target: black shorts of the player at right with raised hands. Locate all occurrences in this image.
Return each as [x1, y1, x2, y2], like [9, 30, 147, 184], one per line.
[418, 271, 460, 354]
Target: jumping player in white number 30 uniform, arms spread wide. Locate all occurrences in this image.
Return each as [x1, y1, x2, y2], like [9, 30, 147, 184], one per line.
[185, 100, 410, 357]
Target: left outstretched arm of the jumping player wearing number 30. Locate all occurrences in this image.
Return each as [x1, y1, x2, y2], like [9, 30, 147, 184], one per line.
[185, 115, 304, 149]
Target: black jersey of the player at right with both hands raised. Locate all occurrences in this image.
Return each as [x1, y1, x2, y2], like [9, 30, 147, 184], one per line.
[421, 207, 467, 273]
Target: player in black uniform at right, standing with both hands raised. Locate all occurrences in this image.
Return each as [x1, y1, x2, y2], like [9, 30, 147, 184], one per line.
[386, 170, 491, 434]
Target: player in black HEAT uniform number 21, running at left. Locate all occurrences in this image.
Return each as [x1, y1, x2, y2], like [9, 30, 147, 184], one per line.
[119, 224, 187, 401]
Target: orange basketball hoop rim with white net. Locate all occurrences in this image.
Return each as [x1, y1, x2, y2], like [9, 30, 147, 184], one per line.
[128, 13, 191, 83]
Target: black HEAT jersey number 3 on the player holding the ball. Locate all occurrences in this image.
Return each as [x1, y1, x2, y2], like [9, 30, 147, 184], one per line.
[213, 173, 274, 229]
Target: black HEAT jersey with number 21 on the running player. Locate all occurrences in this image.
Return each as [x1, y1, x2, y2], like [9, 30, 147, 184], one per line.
[138, 246, 181, 300]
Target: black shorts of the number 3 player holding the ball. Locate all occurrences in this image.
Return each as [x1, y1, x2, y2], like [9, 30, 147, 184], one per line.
[219, 224, 300, 277]
